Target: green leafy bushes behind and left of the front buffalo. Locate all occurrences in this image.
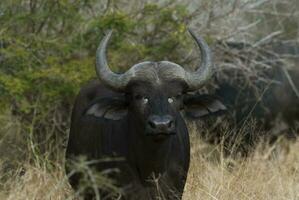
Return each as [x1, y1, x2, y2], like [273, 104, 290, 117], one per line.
[0, 0, 198, 161]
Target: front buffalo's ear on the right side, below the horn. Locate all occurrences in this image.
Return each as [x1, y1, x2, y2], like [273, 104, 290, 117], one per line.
[184, 94, 226, 119]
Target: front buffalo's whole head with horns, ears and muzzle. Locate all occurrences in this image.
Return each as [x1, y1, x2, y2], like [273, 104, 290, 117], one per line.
[86, 30, 225, 139]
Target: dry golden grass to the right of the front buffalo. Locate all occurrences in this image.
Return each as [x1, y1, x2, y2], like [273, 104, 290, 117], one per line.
[184, 125, 299, 200]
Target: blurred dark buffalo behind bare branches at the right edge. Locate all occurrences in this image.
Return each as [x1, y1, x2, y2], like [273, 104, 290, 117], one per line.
[215, 42, 299, 143]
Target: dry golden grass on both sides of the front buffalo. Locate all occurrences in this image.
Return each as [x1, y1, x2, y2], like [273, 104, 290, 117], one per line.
[0, 123, 299, 200]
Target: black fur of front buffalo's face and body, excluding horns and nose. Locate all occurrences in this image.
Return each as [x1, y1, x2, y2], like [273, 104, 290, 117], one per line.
[66, 81, 225, 199]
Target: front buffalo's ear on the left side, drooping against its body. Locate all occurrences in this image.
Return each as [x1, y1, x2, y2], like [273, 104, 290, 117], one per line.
[85, 97, 128, 120]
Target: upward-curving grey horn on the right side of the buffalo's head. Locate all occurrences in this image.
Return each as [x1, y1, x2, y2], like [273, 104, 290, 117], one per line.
[185, 29, 213, 90]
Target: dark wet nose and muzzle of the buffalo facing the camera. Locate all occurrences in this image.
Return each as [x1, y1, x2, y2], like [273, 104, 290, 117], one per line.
[148, 115, 174, 134]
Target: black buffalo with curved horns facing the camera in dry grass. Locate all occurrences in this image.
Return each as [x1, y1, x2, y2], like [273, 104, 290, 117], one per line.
[66, 28, 225, 199]
